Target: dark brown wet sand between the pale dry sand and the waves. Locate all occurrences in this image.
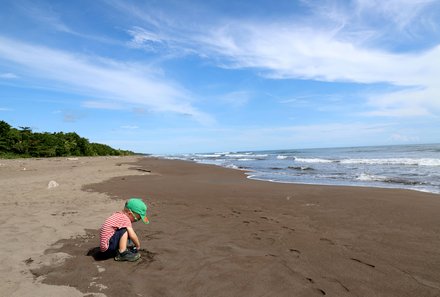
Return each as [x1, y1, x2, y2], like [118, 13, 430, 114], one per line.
[26, 157, 440, 297]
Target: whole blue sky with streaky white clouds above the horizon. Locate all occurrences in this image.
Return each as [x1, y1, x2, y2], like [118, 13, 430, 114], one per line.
[0, 0, 440, 154]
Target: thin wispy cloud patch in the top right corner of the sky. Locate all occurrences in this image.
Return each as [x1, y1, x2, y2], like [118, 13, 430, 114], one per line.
[302, 0, 438, 40]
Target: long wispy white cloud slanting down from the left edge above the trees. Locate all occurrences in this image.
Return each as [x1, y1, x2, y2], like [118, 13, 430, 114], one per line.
[0, 37, 213, 123]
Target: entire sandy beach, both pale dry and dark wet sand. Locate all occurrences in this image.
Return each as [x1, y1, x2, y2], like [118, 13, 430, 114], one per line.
[0, 157, 440, 296]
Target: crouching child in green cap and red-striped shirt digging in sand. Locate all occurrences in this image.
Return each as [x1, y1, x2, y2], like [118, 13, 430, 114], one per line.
[99, 198, 149, 261]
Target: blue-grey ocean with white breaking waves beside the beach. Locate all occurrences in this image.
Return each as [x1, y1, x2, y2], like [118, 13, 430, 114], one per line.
[161, 144, 440, 194]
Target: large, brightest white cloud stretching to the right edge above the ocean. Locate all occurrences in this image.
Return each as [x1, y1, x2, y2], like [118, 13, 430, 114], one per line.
[193, 19, 440, 116]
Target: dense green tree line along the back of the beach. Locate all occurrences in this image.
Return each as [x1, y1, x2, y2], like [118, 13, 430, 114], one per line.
[0, 121, 134, 158]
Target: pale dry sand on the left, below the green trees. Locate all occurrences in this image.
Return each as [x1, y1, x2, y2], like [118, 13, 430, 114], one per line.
[0, 157, 142, 297]
